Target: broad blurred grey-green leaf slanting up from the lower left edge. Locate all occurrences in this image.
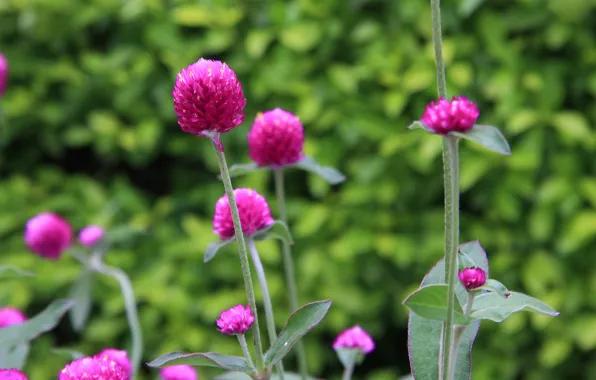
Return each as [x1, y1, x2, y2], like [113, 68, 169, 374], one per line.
[0, 300, 74, 347]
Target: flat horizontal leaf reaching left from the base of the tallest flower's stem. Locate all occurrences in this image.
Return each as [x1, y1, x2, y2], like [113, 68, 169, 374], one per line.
[147, 352, 254, 372]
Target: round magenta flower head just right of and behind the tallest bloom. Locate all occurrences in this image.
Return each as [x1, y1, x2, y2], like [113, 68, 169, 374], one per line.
[248, 108, 304, 167]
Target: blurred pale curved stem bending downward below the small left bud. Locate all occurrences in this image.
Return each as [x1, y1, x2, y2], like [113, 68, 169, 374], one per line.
[92, 256, 143, 378]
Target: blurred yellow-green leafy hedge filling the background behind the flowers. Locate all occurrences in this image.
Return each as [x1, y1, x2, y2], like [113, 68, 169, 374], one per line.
[0, 0, 596, 380]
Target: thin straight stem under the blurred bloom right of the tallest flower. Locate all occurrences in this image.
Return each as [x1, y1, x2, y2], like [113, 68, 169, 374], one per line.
[273, 168, 308, 380]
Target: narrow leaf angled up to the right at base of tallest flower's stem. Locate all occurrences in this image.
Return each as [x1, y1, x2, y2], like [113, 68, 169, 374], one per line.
[265, 300, 331, 366]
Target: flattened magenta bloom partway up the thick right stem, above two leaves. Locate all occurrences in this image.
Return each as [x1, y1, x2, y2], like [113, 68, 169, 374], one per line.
[420, 96, 480, 135]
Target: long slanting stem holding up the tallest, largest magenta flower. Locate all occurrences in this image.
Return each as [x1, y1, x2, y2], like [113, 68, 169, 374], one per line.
[212, 141, 263, 372]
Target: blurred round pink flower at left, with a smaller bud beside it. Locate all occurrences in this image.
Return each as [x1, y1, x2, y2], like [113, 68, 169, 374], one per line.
[25, 212, 72, 260]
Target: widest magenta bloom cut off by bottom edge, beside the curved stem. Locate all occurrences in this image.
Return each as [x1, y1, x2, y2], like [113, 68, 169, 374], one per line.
[58, 355, 130, 380]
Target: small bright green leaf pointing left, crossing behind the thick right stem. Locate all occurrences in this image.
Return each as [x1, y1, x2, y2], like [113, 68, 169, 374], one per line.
[404, 285, 469, 325]
